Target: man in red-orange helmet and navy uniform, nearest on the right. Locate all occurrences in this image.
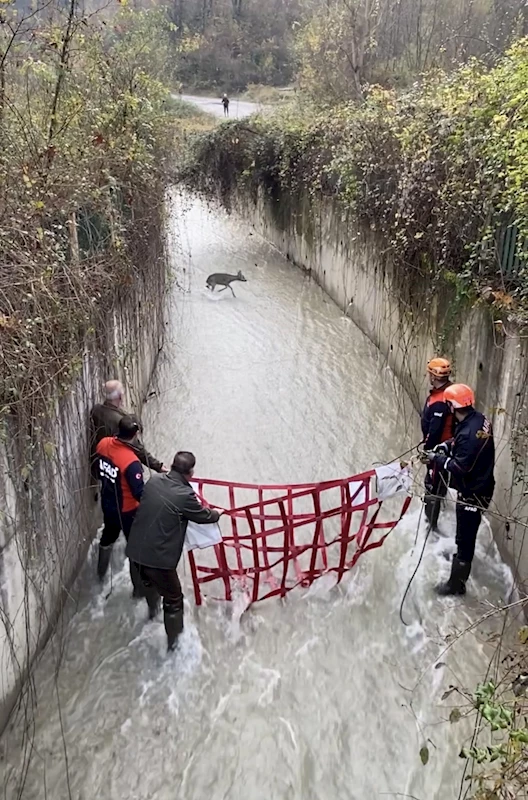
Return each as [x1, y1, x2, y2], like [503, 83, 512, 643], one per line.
[426, 383, 495, 596]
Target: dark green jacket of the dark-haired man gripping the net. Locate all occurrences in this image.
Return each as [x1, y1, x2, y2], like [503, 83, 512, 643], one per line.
[126, 470, 220, 569]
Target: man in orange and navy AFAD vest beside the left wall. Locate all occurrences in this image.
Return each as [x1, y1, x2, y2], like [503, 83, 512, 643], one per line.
[97, 417, 144, 597]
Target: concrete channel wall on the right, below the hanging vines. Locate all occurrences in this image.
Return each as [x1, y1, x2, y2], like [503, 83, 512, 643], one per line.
[244, 195, 528, 589]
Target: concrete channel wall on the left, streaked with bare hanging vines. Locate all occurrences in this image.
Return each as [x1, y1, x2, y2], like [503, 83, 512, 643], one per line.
[0, 258, 166, 732]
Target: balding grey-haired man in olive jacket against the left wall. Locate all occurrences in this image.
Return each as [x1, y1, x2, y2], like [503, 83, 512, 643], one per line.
[90, 381, 168, 481]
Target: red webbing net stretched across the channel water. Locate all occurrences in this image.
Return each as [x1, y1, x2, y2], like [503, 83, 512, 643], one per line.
[188, 470, 410, 605]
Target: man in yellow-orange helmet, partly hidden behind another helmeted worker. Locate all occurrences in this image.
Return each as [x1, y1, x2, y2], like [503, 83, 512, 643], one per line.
[422, 358, 454, 531]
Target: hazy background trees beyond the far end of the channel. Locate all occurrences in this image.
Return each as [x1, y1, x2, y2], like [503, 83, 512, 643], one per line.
[168, 0, 528, 94]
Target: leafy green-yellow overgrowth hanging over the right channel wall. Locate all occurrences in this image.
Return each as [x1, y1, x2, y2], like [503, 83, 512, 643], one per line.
[186, 40, 528, 313]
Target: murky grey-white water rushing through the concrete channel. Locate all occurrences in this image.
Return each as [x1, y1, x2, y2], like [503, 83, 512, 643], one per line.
[0, 194, 511, 800]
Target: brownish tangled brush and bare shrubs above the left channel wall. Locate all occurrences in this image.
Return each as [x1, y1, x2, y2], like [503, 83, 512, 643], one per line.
[0, 0, 172, 418]
